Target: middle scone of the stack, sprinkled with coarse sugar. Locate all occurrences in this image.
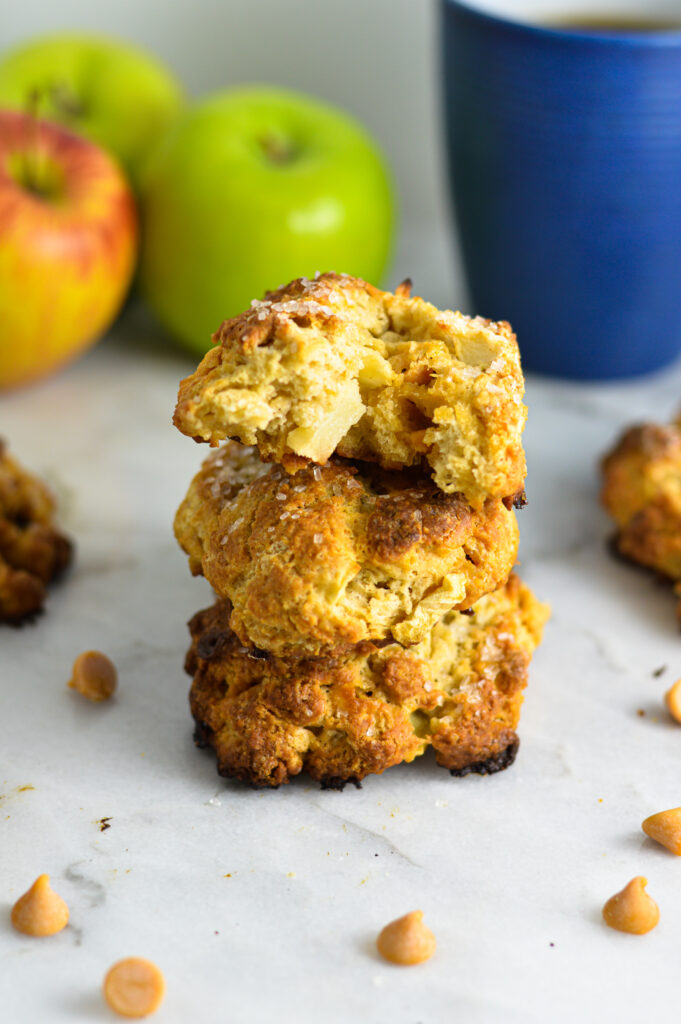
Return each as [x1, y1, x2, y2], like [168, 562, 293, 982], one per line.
[175, 442, 517, 655]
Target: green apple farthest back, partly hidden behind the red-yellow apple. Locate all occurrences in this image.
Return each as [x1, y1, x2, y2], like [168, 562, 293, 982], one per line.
[0, 34, 182, 184]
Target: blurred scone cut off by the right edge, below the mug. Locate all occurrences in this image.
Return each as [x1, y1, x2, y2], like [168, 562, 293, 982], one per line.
[601, 413, 681, 617]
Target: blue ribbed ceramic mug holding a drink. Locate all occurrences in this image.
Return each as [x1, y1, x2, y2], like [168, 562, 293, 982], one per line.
[441, 0, 681, 379]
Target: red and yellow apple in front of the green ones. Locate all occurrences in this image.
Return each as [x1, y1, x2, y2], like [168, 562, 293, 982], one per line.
[0, 111, 137, 389]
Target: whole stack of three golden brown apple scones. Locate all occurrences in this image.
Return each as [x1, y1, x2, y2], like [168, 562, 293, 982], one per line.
[174, 273, 548, 787]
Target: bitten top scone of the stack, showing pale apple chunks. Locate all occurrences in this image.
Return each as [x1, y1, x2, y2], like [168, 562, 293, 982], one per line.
[174, 273, 526, 508]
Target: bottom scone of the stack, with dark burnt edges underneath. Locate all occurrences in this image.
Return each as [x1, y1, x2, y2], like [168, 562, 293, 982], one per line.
[185, 575, 548, 787]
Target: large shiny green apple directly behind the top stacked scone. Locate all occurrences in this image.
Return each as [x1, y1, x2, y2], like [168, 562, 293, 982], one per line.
[139, 86, 393, 353]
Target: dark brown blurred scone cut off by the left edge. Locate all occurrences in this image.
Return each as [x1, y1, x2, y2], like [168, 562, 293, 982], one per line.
[0, 440, 72, 623]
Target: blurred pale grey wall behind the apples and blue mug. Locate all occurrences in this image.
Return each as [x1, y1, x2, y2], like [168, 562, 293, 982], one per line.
[0, 0, 462, 312]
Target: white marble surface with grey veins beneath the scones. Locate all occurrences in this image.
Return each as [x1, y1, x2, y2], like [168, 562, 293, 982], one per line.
[0, 305, 681, 1024]
